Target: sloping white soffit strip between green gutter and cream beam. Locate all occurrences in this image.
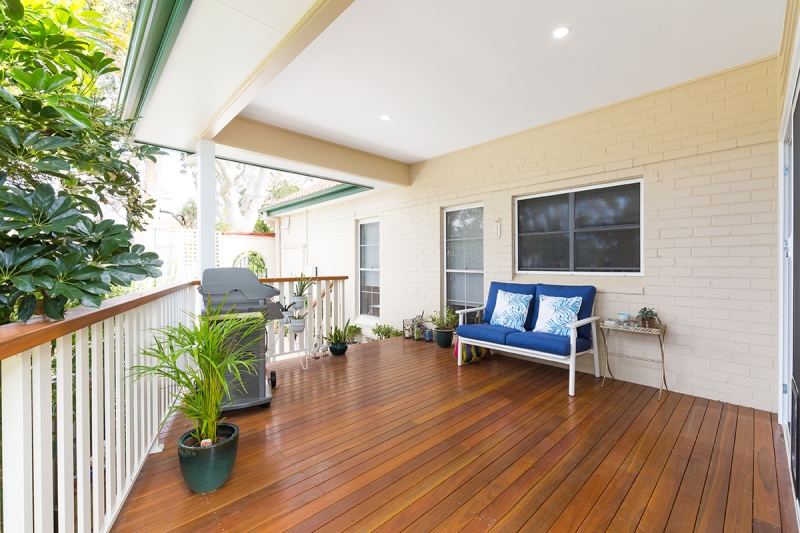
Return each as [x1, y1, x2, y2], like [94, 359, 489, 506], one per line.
[136, 0, 314, 150]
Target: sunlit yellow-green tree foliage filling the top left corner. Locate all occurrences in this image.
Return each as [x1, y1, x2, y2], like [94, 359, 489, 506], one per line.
[0, 0, 158, 229]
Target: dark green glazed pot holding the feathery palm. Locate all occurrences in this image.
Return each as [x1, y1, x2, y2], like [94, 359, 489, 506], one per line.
[178, 423, 239, 494]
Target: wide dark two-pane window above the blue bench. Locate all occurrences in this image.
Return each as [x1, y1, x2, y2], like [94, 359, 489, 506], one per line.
[517, 181, 642, 273]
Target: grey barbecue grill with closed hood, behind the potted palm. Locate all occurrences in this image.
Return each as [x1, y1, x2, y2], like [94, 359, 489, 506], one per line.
[197, 268, 283, 411]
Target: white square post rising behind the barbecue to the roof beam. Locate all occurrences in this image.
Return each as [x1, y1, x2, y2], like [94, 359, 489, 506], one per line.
[197, 139, 217, 279]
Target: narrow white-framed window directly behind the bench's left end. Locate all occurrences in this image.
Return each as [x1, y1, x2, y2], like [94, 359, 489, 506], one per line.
[444, 207, 483, 320]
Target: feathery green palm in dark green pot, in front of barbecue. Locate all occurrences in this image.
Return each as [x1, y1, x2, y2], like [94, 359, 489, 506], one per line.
[131, 308, 264, 494]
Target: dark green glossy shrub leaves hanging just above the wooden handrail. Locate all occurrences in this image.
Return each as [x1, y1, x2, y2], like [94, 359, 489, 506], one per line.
[0, 176, 162, 324]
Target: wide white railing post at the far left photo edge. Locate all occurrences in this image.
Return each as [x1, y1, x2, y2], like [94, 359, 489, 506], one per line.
[2, 350, 33, 533]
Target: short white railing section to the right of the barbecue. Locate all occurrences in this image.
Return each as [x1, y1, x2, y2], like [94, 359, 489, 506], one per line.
[261, 276, 347, 361]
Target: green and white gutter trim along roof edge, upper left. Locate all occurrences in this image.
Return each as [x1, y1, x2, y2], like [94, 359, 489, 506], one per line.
[117, 0, 192, 118]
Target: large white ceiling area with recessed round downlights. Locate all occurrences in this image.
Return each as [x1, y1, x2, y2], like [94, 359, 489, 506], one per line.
[239, 0, 786, 163]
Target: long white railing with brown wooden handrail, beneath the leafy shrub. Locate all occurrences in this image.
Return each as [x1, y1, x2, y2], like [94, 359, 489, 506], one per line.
[0, 283, 196, 533]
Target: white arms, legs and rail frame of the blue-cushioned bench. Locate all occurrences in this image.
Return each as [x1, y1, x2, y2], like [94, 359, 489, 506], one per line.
[456, 306, 600, 396]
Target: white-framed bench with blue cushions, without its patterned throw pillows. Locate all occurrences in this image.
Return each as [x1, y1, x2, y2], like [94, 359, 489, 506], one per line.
[456, 281, 600, 396]
